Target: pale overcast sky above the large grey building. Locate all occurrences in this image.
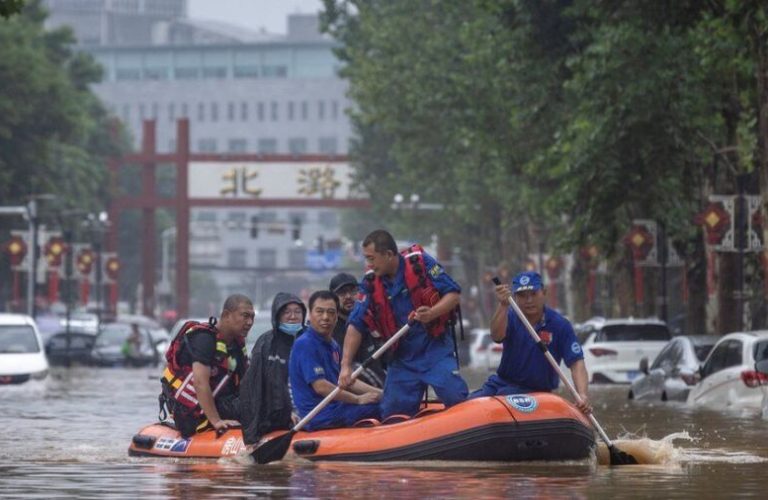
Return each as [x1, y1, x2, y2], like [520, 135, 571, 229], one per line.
[187, 0, 323, 34]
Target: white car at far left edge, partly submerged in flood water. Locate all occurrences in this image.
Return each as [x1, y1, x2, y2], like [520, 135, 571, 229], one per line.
[0, 314, 48, 385]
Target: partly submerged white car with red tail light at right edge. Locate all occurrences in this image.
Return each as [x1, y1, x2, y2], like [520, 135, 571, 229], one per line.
[687, 330, 768, 410]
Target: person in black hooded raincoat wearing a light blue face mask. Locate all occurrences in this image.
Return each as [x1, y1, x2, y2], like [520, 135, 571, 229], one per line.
[240, 292, 307, 444]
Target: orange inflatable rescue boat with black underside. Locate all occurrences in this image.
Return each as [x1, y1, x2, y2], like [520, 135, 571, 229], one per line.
[128, 393, 595, 462]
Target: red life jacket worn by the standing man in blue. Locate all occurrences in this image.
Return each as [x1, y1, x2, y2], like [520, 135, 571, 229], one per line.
[363, 245, 453, 340]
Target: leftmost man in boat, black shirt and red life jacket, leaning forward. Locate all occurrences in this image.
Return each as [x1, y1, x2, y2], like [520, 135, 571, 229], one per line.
[161, 294, 255, 438]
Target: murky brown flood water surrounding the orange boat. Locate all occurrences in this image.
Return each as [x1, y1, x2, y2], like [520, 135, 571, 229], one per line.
[0, 368, 768, 499]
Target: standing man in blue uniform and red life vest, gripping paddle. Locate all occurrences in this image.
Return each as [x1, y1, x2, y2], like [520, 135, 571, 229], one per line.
[339, 230, 468, 418]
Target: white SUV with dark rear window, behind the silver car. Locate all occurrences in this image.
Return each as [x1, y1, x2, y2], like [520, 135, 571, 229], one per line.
[578, 318, 672, 384]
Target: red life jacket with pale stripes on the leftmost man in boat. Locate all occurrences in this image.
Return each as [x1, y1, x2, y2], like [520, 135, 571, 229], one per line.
[161, 321, 248, 417]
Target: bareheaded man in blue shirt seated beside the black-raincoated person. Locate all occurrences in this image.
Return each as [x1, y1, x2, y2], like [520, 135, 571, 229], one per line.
[288, 290, 381, 431]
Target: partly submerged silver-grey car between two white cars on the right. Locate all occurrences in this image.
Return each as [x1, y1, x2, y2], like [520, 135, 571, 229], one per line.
[629, 335, 720, 401]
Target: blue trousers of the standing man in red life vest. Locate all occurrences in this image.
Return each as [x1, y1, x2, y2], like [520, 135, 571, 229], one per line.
[381, 355, 469, 418]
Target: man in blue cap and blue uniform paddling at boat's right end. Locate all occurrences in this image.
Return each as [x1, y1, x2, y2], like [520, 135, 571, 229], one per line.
[469, 271, 592, 413]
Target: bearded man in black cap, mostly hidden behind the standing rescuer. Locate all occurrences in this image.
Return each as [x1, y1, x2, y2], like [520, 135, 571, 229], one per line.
[329, 273, 387, 389]
